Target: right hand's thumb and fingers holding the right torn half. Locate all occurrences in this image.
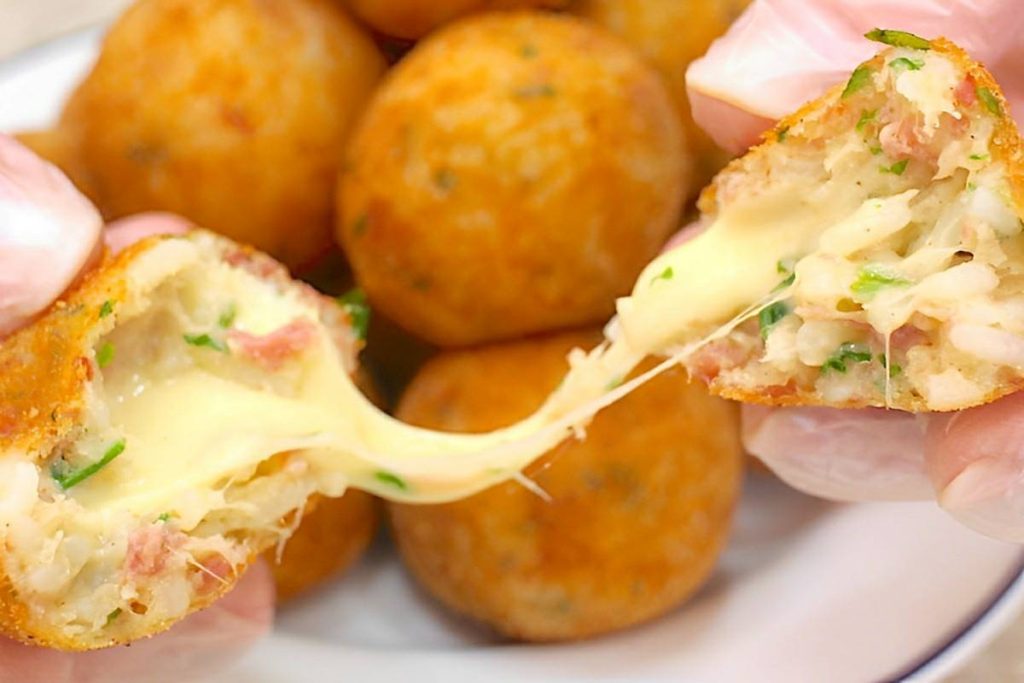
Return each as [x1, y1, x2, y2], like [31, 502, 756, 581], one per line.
[674, 0, 1024, 542]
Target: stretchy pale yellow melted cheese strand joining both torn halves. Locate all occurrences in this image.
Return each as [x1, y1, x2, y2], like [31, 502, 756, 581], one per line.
[66, 171, 913, 528]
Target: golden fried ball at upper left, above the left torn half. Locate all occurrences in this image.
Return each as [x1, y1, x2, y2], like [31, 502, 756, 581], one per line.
[60, 0, 385, 266]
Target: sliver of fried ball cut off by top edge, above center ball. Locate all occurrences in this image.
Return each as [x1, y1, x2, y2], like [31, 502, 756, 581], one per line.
[347, 0, 571, 40]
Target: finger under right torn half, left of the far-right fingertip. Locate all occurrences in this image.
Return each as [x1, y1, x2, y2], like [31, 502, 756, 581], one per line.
[742, 405, 934, 501]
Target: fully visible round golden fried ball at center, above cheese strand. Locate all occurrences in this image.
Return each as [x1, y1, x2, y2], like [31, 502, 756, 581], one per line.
[338, 12, 687, 347]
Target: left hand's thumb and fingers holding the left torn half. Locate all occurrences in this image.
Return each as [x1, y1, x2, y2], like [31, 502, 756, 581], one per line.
[0, 135, 274, 683]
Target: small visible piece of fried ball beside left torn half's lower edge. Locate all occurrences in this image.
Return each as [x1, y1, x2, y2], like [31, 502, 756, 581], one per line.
[266, 488, 380, 602]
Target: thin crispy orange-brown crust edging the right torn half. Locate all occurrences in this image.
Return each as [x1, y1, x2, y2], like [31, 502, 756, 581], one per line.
[697, 38, 1024, 413]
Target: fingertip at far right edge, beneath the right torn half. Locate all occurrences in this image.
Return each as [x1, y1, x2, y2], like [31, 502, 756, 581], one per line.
[925, 393, 1024, 543]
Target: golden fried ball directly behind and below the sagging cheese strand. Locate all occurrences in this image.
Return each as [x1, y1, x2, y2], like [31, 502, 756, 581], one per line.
[390, 333, 740, 641]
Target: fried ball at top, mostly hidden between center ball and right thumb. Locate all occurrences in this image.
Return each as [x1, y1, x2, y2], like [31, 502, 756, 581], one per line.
[570, 0, 750, 190]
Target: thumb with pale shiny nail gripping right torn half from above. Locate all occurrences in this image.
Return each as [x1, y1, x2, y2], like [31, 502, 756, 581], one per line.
[686, 0, 1024, 153]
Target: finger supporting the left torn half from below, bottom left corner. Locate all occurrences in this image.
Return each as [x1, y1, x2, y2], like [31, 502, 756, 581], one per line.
[0, 563, 274, 683]
